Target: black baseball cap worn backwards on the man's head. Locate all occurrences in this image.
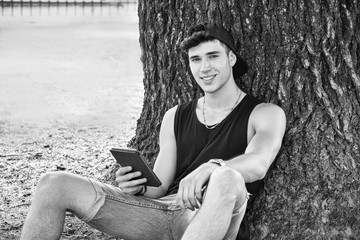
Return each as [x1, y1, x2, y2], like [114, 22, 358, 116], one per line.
[184, 22, 249, 78]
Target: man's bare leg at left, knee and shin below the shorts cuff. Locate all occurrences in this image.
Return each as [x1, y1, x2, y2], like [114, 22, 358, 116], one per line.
[20, 172, 96, 240]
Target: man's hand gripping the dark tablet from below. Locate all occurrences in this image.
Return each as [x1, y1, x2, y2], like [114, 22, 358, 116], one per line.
[115, 166, 147, 195]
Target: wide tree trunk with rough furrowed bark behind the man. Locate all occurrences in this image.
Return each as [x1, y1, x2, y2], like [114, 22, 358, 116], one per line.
[131, 0, 360, 239]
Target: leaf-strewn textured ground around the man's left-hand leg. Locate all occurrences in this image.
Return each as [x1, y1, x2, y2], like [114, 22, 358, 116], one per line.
[0, 124, 134, 240]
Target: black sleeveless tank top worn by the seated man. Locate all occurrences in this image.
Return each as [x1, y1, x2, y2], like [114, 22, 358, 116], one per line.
[168, 95, 263, 239]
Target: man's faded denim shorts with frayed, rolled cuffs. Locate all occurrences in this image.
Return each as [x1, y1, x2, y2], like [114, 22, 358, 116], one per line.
[81, 179, 247, 240]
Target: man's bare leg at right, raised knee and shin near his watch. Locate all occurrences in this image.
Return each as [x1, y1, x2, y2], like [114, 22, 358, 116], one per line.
[182, 167, 247, 240]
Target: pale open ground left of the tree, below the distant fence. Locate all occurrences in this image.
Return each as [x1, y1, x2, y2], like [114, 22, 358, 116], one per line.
[0, 4, 143, 239]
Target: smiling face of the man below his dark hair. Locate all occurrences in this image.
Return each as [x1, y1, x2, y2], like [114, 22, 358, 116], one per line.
[188, 40, 236, 93]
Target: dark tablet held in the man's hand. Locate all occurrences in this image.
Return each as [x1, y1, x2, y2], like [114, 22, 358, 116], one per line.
[110, 148, 161, 187]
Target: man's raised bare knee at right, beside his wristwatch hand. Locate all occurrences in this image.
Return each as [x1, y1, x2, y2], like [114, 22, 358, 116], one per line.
[209, 167, 247, 202]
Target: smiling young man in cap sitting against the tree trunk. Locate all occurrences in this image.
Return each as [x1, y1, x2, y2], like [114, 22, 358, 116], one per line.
[21, 23, 285, 240]
